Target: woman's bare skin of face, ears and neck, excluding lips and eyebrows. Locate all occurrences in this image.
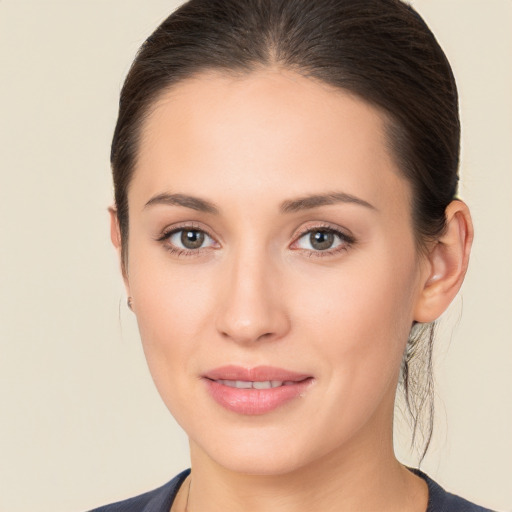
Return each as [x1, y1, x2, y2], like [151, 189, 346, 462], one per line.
[111, 68, 472, 512]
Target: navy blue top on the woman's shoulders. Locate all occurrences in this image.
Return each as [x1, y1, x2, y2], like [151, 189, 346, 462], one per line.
[90, 469, 492, 512]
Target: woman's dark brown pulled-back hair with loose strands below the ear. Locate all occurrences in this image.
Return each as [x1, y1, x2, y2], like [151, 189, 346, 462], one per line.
[111, 0, 460, 455]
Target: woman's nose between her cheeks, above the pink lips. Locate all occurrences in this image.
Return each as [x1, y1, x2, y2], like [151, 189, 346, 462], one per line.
[216, 251, 290, 344]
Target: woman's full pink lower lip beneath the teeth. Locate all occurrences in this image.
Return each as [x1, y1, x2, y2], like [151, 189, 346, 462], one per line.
[205, 378, 313, 415]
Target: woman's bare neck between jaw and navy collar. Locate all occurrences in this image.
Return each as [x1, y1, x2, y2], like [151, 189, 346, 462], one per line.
[188, 424, 428, 512]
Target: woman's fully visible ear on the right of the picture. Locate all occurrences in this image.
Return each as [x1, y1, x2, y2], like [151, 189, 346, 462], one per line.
[414, 199, 473, 323]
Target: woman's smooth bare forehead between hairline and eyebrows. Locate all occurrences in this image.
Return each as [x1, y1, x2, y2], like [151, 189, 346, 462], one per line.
[131, 69, 408, 214]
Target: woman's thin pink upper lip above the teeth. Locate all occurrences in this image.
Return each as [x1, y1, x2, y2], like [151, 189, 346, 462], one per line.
[204, 365, 312, 382]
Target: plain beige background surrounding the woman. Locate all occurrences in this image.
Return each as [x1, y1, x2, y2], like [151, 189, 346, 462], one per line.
[0, 0, 512, 512]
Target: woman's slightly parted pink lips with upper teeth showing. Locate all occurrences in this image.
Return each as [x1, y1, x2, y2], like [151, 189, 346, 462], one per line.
[203, 366, 313, 415]
